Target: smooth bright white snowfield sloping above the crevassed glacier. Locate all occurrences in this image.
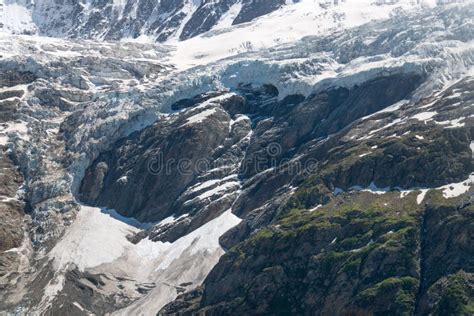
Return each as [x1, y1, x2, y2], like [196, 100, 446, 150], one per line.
[172, 0, 436, 69]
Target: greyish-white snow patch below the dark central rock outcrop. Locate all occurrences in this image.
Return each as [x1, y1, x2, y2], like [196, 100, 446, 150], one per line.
[38, 206, 241, 315]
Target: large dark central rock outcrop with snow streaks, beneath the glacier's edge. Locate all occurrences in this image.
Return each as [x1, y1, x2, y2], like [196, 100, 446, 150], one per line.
[80, 74, 430, 240]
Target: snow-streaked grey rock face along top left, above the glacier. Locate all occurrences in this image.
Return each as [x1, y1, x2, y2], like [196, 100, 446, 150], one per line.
[5, 0, 285, 42]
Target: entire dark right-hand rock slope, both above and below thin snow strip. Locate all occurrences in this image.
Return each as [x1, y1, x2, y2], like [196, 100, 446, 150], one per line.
[160, 64, 473, 315]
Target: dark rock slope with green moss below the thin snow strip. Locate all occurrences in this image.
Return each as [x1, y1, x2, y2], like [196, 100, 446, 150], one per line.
[159, 193, 474, 315]
